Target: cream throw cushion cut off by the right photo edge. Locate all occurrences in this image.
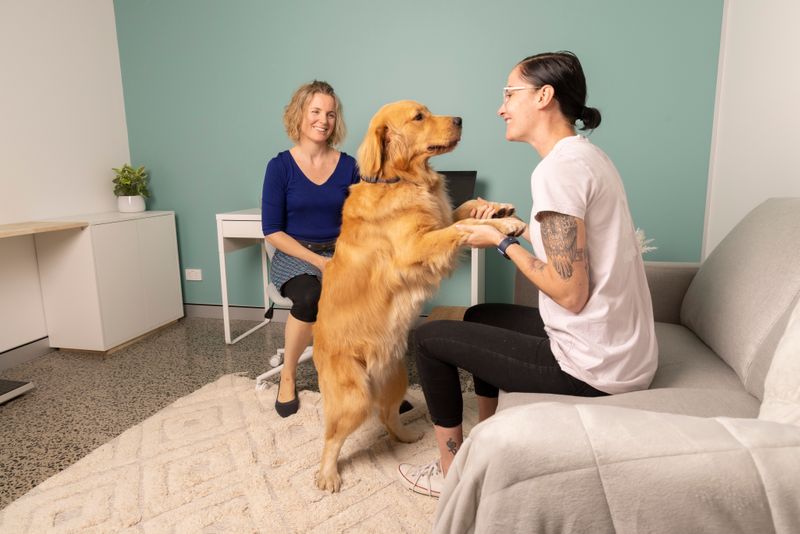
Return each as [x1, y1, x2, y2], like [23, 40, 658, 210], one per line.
[758, 303, 800, 426]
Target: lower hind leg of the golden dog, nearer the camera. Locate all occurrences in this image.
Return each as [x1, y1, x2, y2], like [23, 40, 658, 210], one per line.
[317, 374, 370, 492]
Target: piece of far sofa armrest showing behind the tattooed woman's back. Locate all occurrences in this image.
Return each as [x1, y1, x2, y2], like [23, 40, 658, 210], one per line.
[644, 261, 700, 324]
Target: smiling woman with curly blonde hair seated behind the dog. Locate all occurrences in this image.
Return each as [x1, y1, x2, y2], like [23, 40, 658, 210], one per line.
[261, 80, 359, 417]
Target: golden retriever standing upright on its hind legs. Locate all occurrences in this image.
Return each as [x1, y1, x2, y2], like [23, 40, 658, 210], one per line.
[314, 101, 525, 492]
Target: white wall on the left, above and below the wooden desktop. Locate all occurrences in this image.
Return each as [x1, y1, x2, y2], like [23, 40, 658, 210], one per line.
[0, 0, 130, 358]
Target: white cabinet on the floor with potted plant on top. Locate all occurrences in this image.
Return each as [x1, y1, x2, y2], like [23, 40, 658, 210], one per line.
[36, 211, 183, 352]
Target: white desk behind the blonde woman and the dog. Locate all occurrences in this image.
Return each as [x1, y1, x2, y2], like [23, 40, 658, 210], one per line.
[217, 208, 485, 345]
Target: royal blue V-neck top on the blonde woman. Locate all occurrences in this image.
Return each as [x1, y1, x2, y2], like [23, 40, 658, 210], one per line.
[261, 150, 359, 243]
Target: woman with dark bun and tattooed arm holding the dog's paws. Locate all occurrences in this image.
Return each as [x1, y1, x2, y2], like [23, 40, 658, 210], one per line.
[399, 52, 658, 497]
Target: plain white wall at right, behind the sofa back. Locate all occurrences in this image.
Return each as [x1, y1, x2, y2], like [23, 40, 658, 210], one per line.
[708, 0, 800, 258]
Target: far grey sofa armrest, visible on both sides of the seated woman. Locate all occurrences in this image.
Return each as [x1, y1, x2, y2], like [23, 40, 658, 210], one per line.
[514, 261, 700, 324]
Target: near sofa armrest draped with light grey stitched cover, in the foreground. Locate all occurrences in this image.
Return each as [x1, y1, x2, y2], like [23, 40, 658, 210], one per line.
[433, 403, 800, 533]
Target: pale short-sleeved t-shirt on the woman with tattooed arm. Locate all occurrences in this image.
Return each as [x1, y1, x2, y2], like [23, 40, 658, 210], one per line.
[530, 136, 658, 393]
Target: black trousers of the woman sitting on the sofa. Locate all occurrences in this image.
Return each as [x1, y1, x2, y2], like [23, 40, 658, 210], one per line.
[416, 304, 606, 428]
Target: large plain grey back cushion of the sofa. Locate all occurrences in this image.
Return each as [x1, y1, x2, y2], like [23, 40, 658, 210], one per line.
[681, 198, 800, 398]
